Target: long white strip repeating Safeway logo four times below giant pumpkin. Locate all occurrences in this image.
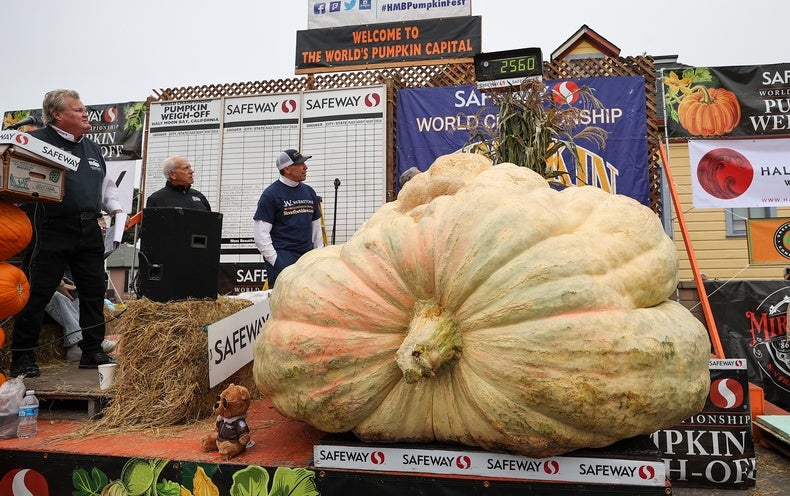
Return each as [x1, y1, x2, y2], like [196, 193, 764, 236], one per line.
[313, 444, 666, 486]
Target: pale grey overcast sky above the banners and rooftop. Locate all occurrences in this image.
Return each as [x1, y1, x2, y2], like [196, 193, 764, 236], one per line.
[0, 0, 790, 111]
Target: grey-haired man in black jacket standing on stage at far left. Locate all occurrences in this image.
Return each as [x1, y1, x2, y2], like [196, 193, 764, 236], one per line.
[11, 89, 120, 377]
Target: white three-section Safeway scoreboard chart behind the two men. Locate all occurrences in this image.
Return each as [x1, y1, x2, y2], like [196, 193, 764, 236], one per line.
[143, 86, 386, 290]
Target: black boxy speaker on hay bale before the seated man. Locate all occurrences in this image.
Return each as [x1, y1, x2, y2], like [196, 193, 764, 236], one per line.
[137, 207, 222, 302]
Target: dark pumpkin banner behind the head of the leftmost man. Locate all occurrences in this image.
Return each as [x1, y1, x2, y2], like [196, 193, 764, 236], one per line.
[3, 102, 145, 161]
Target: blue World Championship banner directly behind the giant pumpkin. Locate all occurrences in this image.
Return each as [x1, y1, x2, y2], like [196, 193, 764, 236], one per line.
[396, 77, 650, 205]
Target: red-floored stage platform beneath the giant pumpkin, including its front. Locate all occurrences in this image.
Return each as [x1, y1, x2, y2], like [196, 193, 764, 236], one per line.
[0, 364, 790, 496]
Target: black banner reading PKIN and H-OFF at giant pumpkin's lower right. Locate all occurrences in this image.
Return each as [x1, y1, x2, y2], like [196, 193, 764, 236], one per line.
[652, 359, 756, 489]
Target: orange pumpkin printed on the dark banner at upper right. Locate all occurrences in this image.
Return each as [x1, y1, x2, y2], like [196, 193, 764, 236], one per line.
[678, 86, 741, 136]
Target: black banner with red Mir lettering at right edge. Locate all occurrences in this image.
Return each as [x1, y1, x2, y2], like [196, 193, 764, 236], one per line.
[705, 280, 790, 410]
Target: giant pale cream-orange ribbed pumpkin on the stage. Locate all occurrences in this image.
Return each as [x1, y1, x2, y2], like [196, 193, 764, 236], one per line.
[253, 154, 710, 457]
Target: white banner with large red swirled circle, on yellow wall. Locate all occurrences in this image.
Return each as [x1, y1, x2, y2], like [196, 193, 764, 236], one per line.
[688, 139, 790, 208]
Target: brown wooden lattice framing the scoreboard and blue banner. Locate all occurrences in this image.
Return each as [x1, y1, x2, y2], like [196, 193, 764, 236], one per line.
[148, 56, 663, 215]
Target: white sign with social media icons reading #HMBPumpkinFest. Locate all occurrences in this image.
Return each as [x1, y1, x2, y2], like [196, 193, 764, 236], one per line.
[307, 0, 472, 29]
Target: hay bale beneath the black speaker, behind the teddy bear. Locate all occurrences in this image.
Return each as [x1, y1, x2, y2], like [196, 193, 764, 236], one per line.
[85, 297, 261, 431]
